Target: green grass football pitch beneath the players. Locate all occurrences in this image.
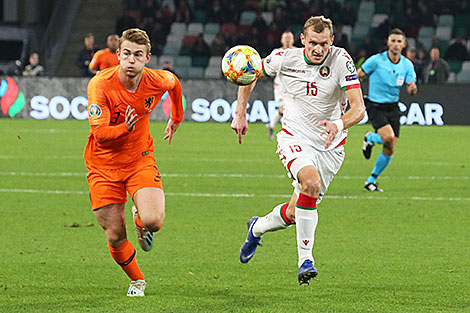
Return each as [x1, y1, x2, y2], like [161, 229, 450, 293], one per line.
[0, 119, 470, 312]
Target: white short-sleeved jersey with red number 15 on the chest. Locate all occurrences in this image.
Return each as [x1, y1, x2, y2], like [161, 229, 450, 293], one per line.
[263, 46, 361, 151]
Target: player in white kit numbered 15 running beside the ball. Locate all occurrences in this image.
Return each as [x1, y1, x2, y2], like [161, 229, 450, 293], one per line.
[232, 16, 365, 285]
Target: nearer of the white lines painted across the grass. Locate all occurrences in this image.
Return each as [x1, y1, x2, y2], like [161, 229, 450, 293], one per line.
[0, 188, 470, 201]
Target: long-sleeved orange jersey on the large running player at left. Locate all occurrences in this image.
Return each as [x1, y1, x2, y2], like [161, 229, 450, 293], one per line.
[84, 66, 184, 169]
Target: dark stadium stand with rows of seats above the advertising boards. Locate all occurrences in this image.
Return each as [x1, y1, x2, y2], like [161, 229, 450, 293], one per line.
[0, 0, 470, 82]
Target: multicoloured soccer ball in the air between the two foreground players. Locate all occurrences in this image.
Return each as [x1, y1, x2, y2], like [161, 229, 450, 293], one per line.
[222, 46, 262, 86]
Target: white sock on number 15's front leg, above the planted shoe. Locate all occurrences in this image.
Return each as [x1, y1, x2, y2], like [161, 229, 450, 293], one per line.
[295, 207, 318, 267]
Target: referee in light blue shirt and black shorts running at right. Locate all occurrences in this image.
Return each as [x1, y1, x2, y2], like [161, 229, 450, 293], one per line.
[357, 28, 418, 192]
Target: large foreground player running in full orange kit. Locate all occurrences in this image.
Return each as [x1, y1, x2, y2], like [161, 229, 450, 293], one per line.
[84, 28, 184, 296]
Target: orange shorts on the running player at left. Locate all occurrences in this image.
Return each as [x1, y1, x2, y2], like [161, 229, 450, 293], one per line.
[87, 164, 163, 210]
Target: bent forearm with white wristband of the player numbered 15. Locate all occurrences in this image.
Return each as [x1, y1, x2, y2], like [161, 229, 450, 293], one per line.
[318, 88, 365, 149]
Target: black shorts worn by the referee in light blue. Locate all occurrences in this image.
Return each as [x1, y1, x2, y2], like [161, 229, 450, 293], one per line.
[365, 99, 401, 138]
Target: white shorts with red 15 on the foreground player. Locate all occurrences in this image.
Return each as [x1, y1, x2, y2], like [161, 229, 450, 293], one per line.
[276, 130, 345, 204]
